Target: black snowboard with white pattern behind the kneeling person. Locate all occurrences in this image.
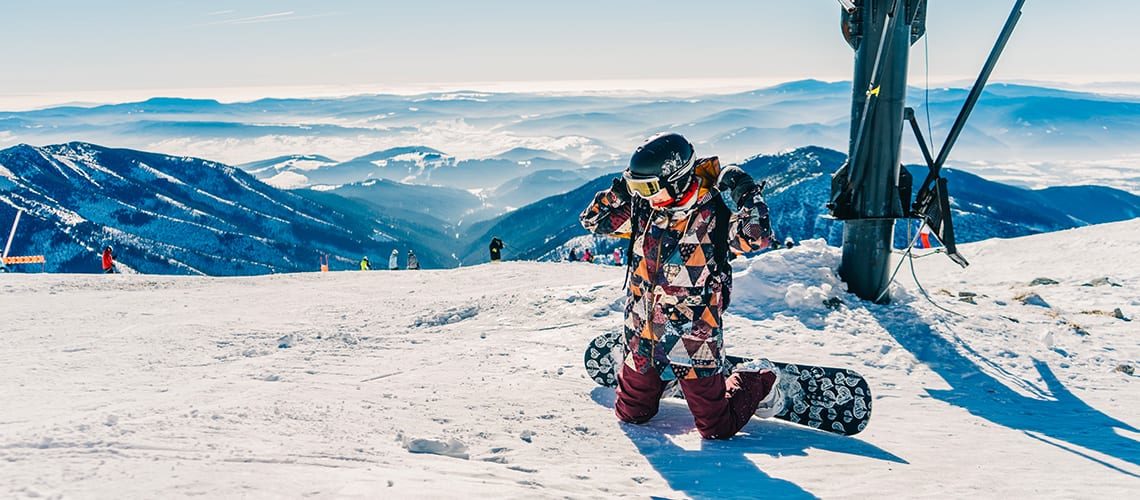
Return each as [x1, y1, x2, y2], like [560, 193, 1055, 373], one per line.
[585, 333, 871, 436]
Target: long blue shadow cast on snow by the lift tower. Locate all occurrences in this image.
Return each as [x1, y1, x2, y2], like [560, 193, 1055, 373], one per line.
[868, 306, 1140, 477]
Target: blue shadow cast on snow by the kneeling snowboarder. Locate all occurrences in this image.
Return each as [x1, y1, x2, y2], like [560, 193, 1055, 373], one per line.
[591, 387, 906, 499]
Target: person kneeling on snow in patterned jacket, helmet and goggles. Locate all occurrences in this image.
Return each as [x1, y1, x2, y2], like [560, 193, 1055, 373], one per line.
[580, 133, 783, 440]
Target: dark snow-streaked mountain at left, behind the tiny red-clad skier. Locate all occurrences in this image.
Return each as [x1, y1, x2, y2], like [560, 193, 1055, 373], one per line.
[0, 142, 451, 276]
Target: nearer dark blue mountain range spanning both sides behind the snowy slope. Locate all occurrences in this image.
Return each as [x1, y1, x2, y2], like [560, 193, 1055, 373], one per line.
[0, 142, 1140, 276]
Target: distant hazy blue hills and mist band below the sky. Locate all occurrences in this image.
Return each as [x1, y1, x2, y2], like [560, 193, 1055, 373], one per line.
[0, 80, 1140, 194]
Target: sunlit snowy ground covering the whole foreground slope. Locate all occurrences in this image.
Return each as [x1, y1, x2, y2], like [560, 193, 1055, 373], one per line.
[0, 220, 1140, 498]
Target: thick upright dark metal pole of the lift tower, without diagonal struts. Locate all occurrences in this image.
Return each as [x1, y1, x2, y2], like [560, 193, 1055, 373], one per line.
[830, 0, 926, 301]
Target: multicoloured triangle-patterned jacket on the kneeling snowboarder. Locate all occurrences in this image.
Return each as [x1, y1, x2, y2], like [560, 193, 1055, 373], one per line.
[580, 157, 772, 379]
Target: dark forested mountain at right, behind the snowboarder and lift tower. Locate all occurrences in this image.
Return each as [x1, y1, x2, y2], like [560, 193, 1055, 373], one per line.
[463, 147, 1140, 263]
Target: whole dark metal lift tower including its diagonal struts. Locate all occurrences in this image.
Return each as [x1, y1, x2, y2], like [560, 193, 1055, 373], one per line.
[828, 0, 1025, 302]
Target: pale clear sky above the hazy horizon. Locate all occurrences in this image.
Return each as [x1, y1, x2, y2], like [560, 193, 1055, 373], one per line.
[0, 0, 1140, 109]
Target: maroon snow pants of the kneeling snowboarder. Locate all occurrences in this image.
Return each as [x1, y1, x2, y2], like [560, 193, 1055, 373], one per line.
[613, 363, 776, 440]
